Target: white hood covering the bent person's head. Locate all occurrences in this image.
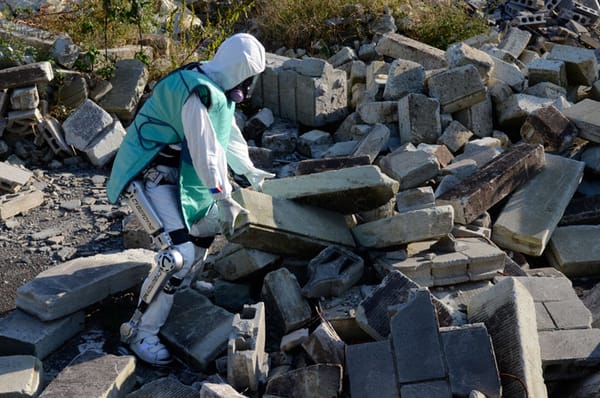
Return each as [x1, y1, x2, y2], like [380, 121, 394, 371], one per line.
[202, 33, 265, 91]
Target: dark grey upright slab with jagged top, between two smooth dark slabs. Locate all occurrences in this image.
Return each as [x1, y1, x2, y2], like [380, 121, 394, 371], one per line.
[390, 288, 448, 384]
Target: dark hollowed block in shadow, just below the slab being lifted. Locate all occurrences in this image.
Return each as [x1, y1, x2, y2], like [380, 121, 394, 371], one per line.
[302, 246, 364, 298]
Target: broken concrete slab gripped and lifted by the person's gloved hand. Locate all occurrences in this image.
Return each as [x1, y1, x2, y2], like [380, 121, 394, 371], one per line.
[229, 189, 355, 258]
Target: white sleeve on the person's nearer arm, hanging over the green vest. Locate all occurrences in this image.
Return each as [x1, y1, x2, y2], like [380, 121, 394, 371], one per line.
[181, 94, 232, 200]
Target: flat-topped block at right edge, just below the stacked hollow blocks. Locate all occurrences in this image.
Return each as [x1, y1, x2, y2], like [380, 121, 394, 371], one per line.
[547, 44, 598, 86]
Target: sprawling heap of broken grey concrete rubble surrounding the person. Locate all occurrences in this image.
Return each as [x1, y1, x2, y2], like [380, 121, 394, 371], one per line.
[0, 0, 600, 398]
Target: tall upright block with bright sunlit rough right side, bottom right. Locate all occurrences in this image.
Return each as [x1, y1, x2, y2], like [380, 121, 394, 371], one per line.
[467, 278, 548, 397]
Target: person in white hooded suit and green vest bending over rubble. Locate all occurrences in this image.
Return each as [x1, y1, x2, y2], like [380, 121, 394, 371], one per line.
[107, 33, 274, 365]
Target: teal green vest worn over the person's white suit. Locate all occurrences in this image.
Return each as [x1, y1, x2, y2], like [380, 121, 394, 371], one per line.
[106, 70, 235, 228]
